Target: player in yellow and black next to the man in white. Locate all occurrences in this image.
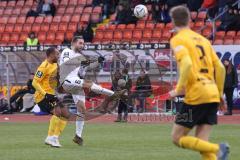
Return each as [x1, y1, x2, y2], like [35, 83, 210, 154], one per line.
[32, 48, 67, 147]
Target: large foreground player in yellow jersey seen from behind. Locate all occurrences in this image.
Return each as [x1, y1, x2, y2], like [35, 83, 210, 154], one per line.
[169, 6, 229, 160]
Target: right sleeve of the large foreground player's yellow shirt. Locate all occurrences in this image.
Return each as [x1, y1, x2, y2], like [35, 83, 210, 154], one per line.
[211, 47, 226, 96]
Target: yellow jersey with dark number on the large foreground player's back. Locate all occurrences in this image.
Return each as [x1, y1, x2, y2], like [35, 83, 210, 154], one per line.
[170, 28, 224, 105]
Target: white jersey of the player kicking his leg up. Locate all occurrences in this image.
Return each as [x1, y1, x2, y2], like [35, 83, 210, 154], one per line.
[59, 48, 86, 83]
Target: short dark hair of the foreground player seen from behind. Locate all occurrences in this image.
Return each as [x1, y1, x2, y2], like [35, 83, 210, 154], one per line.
[170, 5, 190, 27]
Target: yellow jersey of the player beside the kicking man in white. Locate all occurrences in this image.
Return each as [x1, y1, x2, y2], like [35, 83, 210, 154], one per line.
[33, 60, 58, 103]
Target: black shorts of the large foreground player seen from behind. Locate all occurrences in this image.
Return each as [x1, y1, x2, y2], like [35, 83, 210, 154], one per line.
[175, 103, 219, 129]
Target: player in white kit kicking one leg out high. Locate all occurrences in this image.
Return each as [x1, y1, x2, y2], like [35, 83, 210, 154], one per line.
[59, 37, 122, 145]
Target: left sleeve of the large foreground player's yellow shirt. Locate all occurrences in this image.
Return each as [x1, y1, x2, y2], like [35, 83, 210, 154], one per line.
[171, 40, 192, 94]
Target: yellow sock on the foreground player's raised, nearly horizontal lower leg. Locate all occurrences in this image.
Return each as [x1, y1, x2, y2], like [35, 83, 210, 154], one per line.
[179, 136, 219, 153]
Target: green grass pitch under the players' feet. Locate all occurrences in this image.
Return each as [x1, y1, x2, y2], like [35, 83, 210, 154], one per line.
[0, 123, 240, 160]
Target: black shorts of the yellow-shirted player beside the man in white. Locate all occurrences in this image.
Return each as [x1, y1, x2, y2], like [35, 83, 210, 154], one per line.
[37, 98, 64, 114]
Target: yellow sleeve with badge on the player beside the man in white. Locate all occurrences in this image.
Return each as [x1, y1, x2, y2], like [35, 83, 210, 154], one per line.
[32, 67, 46, 95]
